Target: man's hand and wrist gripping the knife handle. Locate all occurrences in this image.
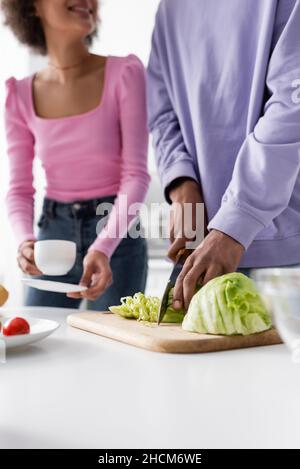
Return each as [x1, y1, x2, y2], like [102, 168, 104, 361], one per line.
[168, 178, 207, 261]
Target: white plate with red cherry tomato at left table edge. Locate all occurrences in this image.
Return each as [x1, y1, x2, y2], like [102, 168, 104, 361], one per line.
[0, 316, 59, 349]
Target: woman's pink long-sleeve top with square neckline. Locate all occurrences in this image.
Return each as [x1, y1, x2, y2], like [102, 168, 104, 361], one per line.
[5, 55, 150, 257]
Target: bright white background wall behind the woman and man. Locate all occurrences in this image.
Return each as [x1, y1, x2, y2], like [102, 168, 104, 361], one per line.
[0, 0, 160, 306]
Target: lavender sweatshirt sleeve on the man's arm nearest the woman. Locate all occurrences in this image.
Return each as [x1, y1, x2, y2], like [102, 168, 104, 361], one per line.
[147, 5, 199, 199]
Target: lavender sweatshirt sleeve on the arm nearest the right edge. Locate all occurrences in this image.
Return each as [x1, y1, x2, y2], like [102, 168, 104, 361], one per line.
[208, 0, 300, 249]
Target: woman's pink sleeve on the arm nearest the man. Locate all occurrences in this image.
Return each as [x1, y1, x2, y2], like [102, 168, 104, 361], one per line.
[90, 55, 150, 257]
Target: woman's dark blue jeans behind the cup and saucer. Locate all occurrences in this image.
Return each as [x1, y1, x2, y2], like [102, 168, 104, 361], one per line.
[25, 196, 148, 311]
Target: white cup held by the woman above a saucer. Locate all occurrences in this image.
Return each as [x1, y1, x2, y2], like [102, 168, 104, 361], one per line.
[34, 239, 76, 275]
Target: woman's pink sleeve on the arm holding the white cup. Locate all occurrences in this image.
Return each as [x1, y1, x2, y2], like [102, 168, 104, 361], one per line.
[5, 78, 35, 245]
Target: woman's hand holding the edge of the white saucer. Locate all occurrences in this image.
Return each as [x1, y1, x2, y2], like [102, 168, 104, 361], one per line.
[67, 251, 112, 301]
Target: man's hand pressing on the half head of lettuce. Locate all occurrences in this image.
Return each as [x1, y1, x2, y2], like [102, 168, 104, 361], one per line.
[173, 230, 244, 310]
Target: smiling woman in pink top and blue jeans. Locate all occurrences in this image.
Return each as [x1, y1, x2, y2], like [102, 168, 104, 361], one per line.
[2, 0, 149, 310]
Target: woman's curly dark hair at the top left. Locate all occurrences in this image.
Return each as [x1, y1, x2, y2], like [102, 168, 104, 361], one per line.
[1, 0, 97, 55]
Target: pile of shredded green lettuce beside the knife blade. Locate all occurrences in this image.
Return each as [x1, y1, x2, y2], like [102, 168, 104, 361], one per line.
[109, 289, 185, 323]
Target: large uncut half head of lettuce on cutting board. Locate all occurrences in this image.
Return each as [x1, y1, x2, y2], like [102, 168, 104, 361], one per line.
[182, 273, 272, 335]
